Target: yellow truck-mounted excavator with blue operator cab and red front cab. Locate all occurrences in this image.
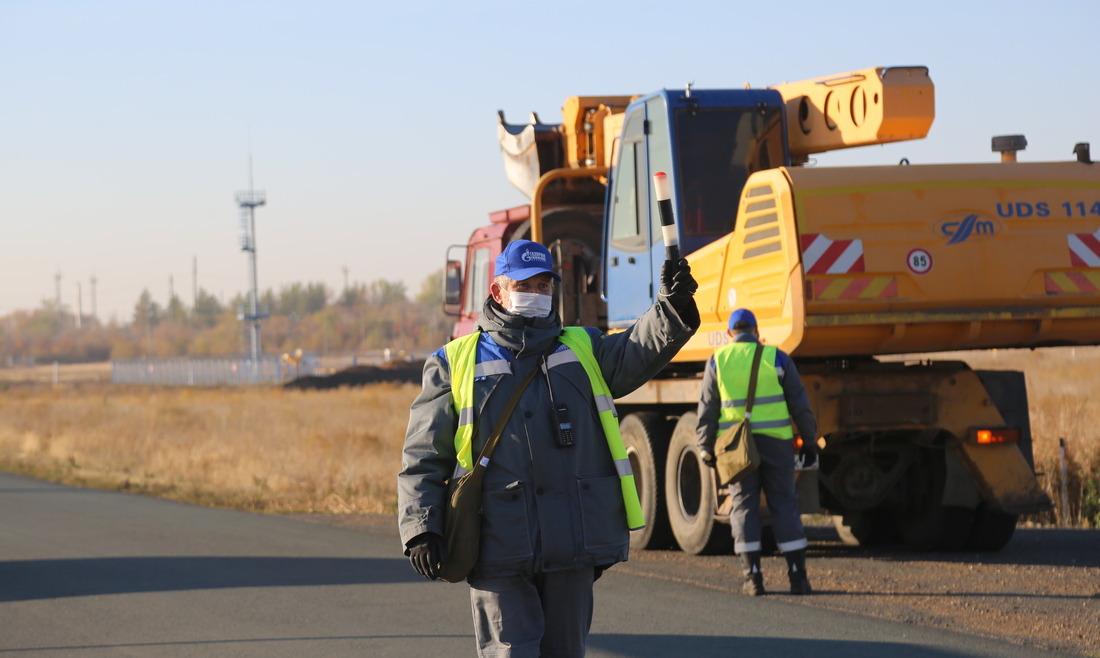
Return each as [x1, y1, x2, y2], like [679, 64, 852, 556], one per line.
[447, 66, 1100, 553]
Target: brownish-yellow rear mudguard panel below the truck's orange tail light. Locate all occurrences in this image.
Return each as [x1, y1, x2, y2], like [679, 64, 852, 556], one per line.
[958, 442, 1054, 514]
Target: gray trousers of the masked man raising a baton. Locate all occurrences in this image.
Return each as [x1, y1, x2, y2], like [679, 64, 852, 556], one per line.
[468, 567, 594, 658]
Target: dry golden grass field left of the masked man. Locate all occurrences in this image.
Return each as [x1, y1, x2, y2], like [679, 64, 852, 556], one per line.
[0, 371, 418, 513]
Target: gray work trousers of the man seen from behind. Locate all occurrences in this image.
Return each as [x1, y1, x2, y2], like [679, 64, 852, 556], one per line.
[729, 432, 806, 555]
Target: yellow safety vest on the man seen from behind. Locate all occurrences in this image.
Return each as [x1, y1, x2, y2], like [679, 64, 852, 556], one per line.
[714, 342, 794, 439]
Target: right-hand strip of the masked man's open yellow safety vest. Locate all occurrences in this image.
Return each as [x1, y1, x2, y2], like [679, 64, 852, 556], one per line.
[559, 327, 646, 530]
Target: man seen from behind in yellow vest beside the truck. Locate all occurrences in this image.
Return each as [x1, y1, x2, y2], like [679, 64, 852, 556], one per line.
[696, 308, 817, 596]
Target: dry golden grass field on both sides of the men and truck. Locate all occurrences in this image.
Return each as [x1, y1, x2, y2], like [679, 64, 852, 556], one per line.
[0, 348, 1100, 526]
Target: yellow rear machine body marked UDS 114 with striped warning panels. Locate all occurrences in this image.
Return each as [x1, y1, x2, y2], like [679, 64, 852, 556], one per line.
[678, 162, 1100, 361]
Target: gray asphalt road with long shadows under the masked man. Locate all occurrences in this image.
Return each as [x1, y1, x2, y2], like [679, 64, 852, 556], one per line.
[0, 474, 1069, 658]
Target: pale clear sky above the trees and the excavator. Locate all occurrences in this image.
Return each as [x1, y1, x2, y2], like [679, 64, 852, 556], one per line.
[0, 0, 1100, 321]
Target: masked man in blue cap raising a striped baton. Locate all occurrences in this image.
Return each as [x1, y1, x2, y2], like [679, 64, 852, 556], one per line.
[397, 240, 700, 656]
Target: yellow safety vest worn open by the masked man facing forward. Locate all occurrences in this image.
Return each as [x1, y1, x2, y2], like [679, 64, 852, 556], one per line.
[443, 327, 646, 530]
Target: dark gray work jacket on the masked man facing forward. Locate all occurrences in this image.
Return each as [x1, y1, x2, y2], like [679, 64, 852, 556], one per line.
[397, 298, 695, 577]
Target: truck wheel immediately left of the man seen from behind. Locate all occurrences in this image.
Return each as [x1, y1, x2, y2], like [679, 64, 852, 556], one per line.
[664, 412, 733, 556]
